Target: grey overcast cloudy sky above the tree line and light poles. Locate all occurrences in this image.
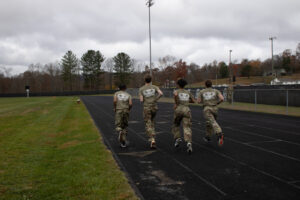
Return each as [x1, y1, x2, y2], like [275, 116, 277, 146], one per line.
[0, 0, 300, 74]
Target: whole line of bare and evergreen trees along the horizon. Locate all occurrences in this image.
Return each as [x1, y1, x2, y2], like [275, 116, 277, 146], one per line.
[0, 43, 300, 93]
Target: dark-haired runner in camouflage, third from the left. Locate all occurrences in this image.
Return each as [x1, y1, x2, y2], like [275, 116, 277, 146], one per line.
[172, 79, 195, 154]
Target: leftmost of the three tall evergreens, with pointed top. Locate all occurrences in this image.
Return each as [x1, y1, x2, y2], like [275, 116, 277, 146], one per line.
[61, 50, 79, 90]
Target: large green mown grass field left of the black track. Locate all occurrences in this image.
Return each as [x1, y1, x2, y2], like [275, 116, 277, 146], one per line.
[0, 97, 137, 200]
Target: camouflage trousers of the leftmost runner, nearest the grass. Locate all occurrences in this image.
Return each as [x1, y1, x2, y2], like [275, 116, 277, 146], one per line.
[115, 109, 129, 141]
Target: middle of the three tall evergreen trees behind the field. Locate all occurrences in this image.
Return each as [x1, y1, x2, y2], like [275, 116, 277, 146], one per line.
[81, 50, 105, 89]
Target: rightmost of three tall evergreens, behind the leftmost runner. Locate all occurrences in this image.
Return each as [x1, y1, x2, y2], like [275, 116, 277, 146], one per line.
[113, 52, 133, 85]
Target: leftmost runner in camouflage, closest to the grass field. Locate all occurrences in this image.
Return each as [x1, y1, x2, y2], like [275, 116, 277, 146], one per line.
[114, 84, 132, 147]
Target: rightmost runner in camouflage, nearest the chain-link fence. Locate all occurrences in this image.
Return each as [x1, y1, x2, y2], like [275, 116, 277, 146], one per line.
[198, 80, 224, 146]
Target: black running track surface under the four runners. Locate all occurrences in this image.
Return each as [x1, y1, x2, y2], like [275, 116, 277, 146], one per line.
[82, 96, 300, 200]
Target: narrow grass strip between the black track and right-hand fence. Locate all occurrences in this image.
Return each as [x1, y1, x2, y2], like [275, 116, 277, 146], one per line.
[159, 98, 300, 117]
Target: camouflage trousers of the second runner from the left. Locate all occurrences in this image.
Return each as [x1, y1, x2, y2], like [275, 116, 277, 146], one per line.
[144, 106, 157, 141]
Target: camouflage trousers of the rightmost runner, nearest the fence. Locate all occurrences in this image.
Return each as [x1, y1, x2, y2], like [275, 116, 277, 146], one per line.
[203, 106, 222, 137]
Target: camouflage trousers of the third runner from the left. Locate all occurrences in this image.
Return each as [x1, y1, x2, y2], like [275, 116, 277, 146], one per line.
[172, 106, 192, 142]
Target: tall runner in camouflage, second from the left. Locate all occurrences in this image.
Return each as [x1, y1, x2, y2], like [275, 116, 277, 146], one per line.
[139, 75, 163, 148]
